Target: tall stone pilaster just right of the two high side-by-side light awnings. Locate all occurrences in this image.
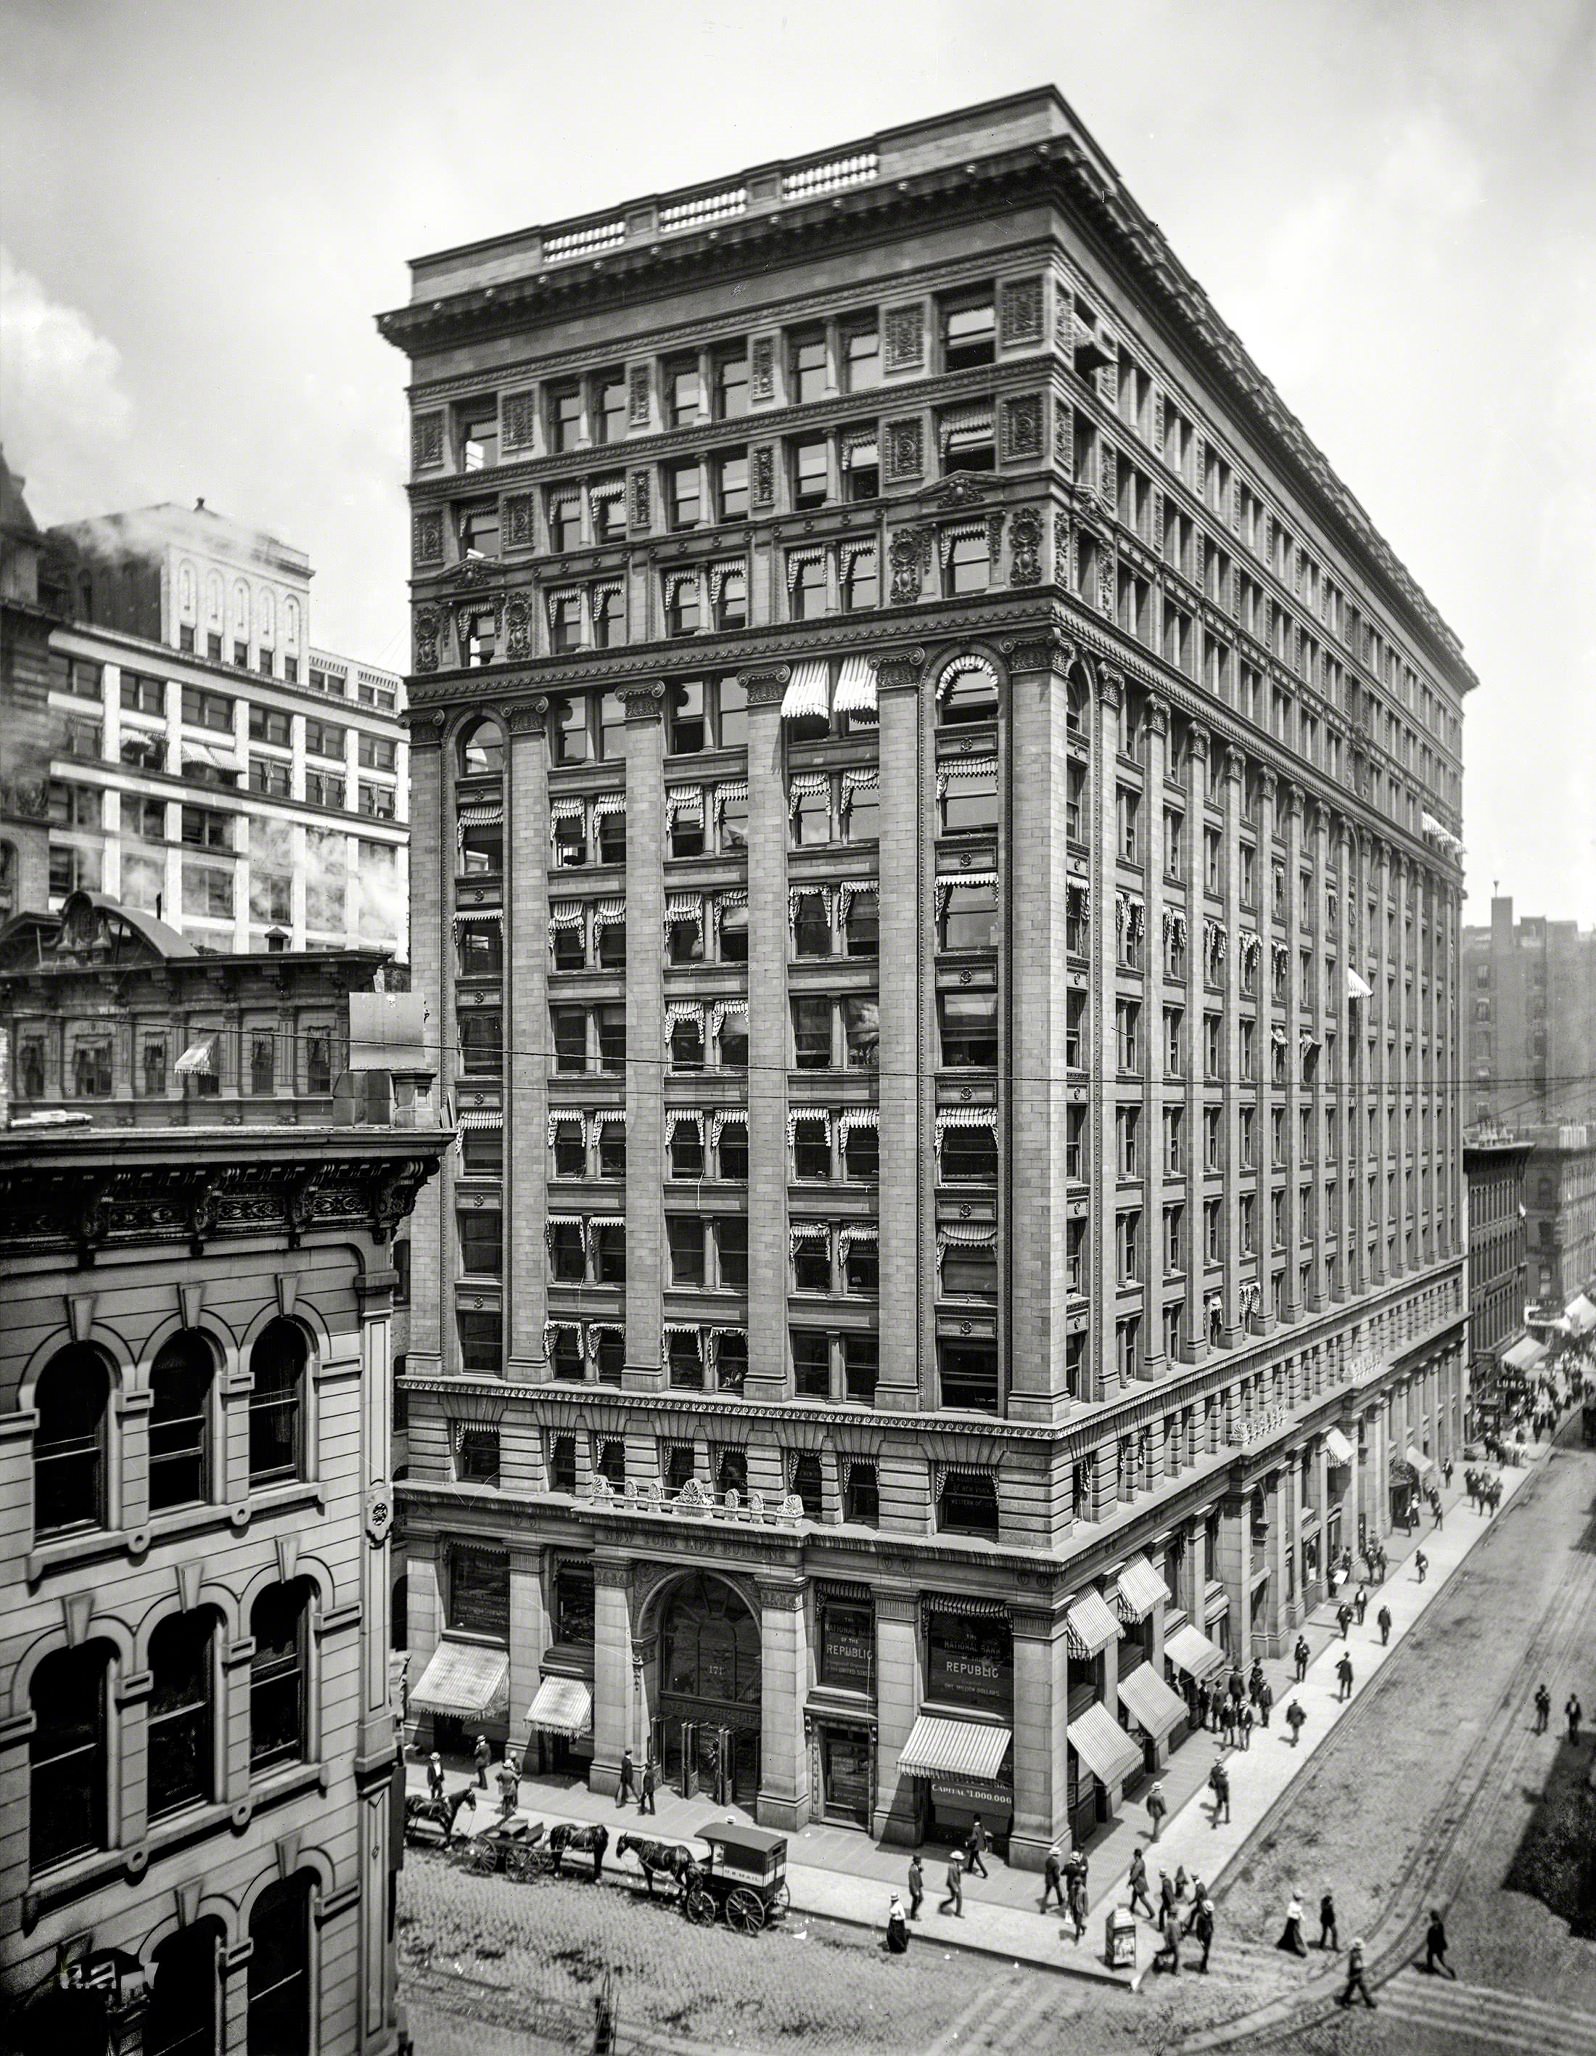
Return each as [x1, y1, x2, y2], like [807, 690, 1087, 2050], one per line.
[880, 650, 936, 1412]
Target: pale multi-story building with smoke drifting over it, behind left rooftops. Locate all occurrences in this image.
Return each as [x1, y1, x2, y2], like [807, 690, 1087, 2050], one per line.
[0, 450, 409, 954]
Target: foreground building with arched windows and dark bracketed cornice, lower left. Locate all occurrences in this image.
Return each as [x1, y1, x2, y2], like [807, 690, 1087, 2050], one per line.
[0, 1102, 448, 2056]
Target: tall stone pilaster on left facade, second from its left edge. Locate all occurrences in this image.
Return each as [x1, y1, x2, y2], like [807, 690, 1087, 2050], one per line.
[502, 697, 551, 1382]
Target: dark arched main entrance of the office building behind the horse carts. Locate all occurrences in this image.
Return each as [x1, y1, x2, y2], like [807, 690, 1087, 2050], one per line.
[654, 1577, 759, 1807]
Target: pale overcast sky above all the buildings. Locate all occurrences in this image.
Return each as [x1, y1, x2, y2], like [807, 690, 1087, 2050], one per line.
[0, 0, 1596, 923]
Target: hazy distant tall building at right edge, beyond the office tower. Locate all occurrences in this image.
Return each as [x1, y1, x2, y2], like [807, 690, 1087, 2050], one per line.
[1462, 898, 1596, 1133]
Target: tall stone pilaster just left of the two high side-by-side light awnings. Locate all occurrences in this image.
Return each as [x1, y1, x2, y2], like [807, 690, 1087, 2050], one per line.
[742, 664, 790, 1400]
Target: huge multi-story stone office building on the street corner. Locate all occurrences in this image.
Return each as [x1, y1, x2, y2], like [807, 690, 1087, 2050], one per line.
[380, 90, 1473, 1865]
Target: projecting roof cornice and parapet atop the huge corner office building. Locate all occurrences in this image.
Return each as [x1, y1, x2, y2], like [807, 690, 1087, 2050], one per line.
[376, 86, 1479, 693]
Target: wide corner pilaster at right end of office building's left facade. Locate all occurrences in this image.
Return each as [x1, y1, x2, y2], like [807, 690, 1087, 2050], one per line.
[1003, 629, 1076, 1421]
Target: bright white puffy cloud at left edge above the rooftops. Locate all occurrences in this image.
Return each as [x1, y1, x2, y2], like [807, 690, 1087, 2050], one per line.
[0, 249, 134, 520]
